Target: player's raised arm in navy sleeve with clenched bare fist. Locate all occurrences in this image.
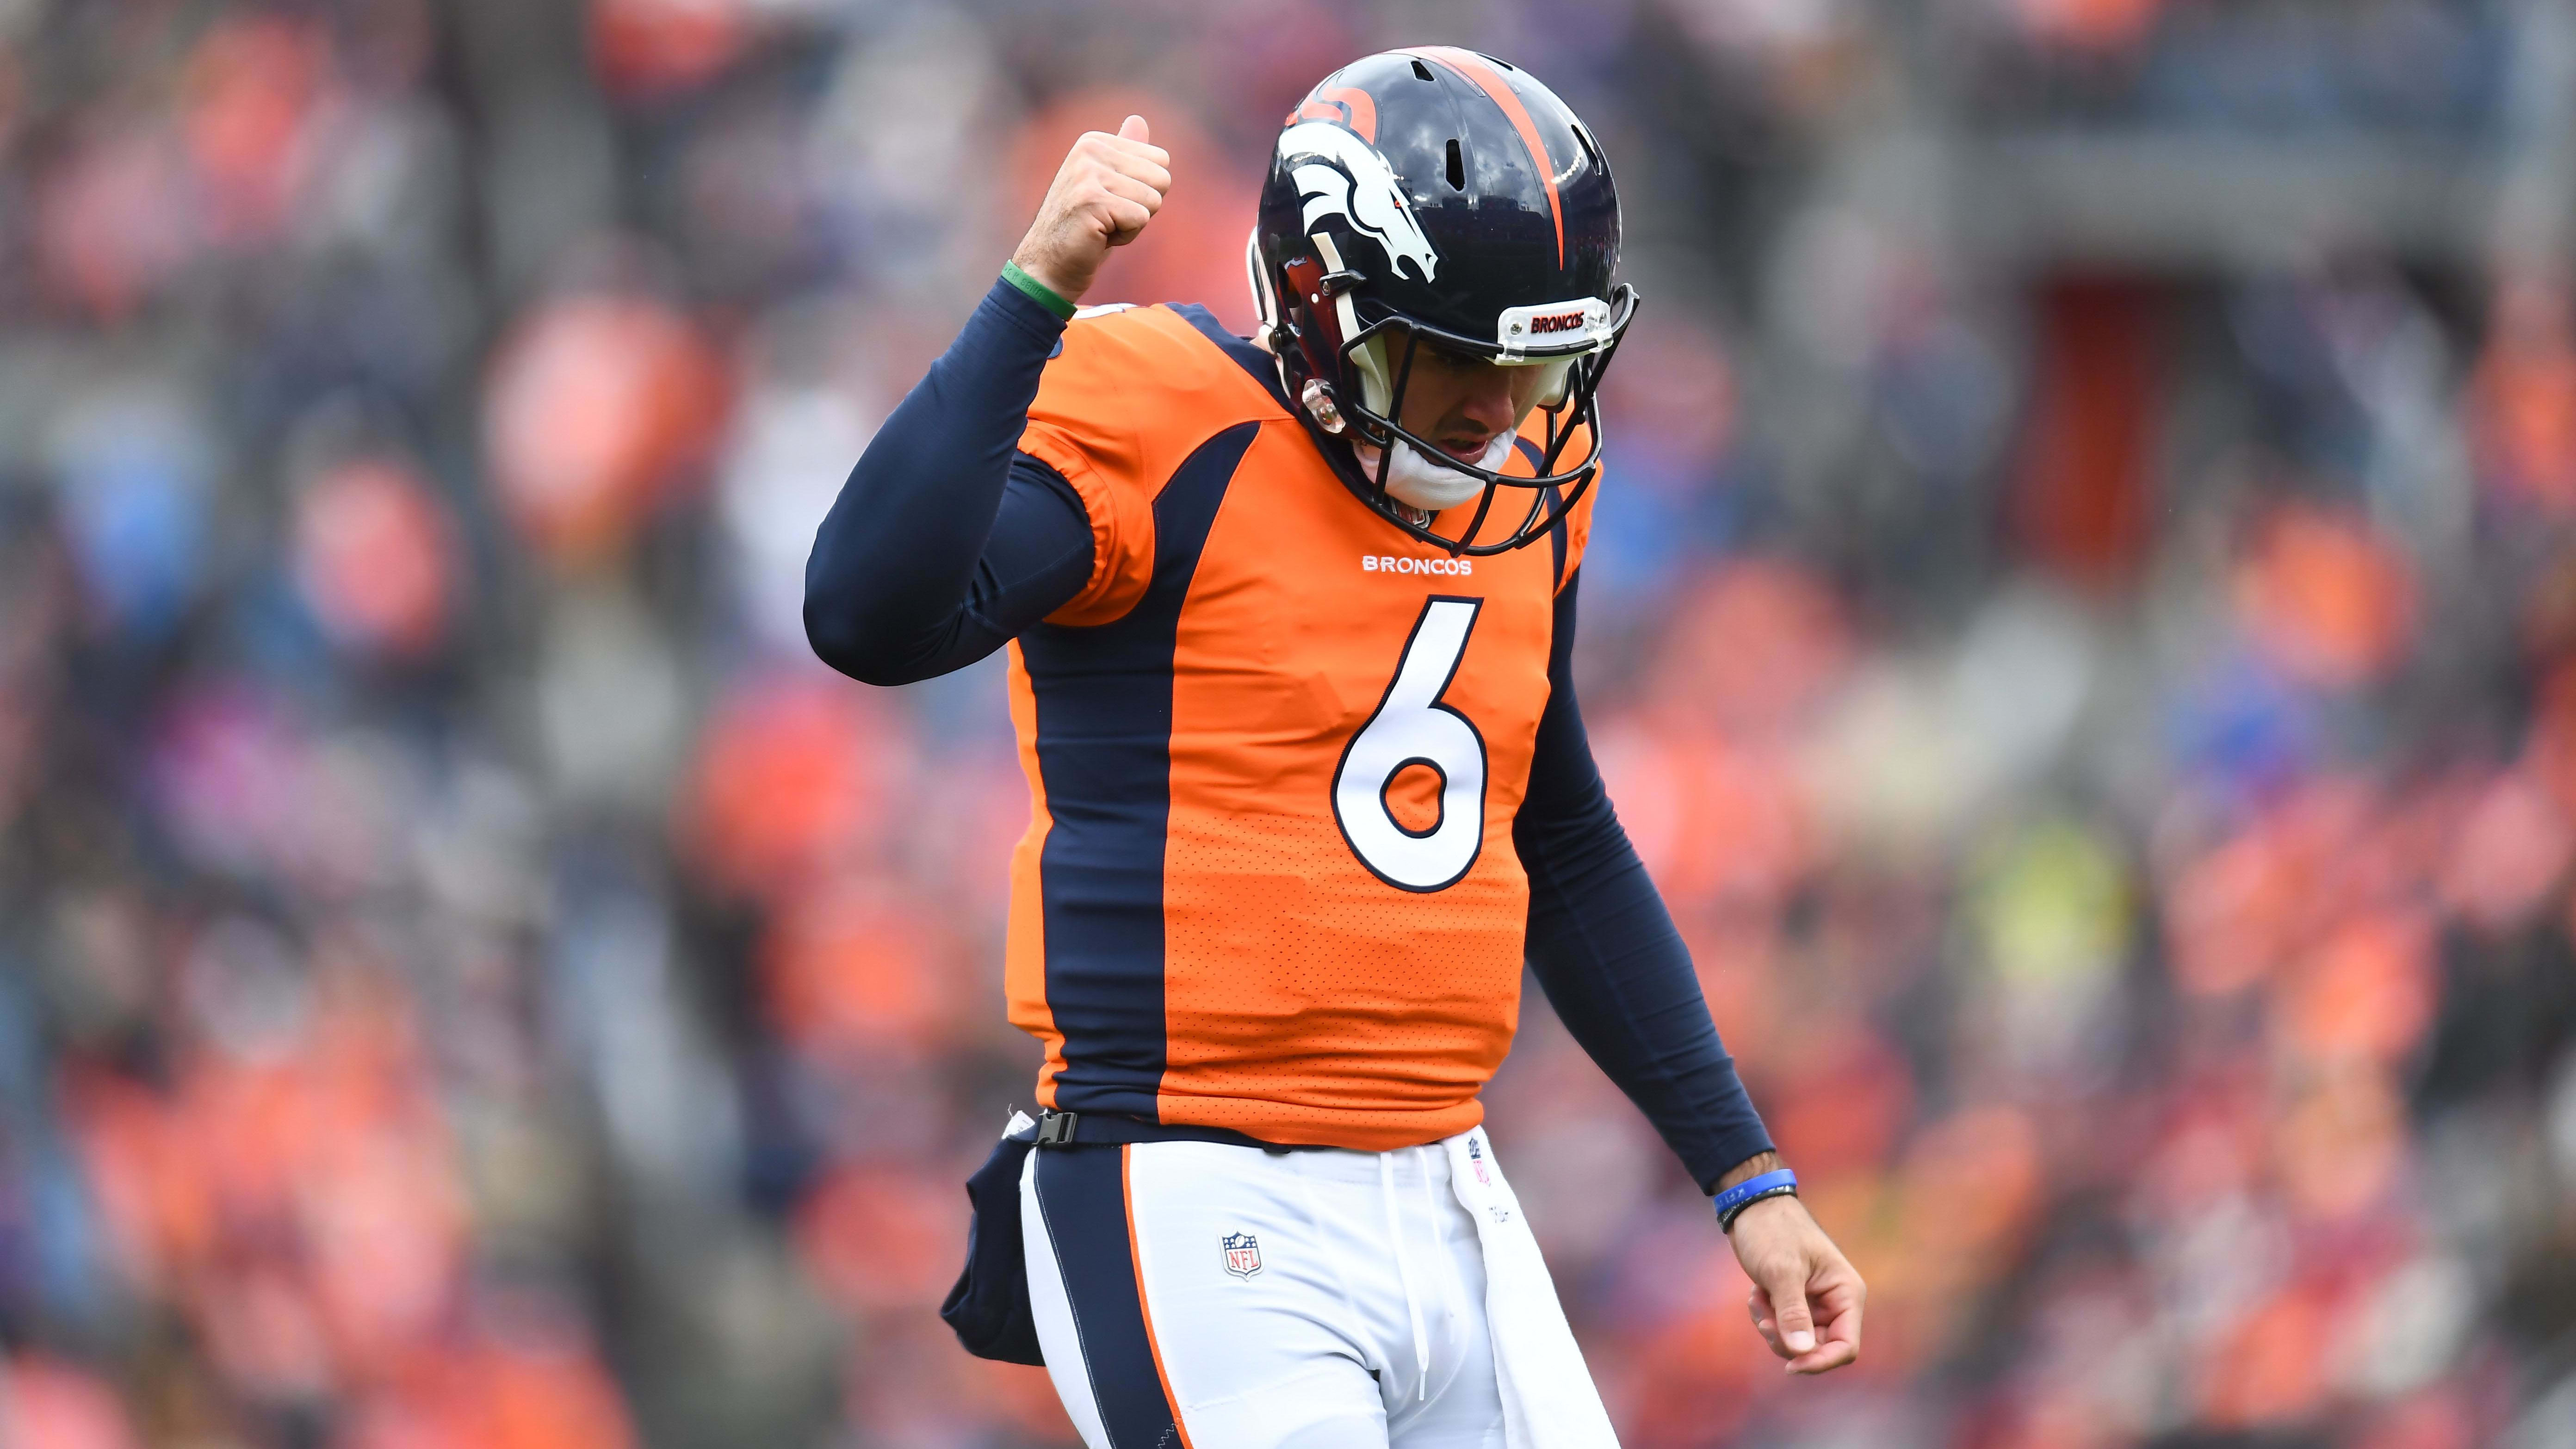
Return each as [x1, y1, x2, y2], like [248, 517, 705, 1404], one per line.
[804, 116, 1172, 683]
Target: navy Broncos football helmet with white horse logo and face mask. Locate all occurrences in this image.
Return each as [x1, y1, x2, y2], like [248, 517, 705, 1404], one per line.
[1244, 46, 1636, 557]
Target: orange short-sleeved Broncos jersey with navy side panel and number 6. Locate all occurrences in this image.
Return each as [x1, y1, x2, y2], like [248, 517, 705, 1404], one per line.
[1007, 307, 1592, 1150]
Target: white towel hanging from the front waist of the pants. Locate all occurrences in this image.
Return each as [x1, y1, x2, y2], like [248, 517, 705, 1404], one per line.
[1443, 1127, 1618, 1449]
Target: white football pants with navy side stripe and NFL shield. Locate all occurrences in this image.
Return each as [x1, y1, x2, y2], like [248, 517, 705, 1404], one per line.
[1020, 1129, 1618, 1449]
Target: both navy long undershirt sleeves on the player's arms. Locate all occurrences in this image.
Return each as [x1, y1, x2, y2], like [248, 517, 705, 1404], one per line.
[804, 271, 1772, 1191]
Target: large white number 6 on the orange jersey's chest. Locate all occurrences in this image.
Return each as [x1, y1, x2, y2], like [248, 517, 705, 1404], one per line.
[1332, 598, 1484, 892]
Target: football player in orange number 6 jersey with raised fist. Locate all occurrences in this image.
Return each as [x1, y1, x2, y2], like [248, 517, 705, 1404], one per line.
[806, 46, 1863, 1449]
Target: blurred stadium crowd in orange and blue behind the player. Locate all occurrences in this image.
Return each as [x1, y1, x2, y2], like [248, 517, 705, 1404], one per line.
[0, 0, 2576, 1449]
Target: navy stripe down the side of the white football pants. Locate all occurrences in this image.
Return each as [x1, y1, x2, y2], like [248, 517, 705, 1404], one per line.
[1038, 1145, 1180, 1449]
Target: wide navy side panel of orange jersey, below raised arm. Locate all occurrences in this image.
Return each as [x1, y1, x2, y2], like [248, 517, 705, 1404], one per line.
[1020, 423, 1260, 1121]
